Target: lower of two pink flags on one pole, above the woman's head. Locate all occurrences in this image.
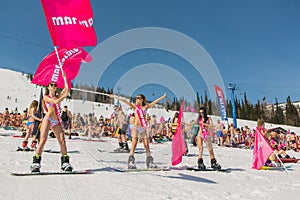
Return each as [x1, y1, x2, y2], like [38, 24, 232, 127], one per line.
[31, 48, 92, 88]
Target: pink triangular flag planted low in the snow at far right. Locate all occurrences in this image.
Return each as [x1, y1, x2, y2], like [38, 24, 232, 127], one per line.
[252, 129, 273, 170]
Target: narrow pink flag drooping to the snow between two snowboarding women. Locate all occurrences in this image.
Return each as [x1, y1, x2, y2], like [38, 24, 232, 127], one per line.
[172, 102, 186, 166]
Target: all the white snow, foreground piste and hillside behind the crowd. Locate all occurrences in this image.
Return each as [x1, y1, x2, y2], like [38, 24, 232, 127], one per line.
[0, 69, 300, 200]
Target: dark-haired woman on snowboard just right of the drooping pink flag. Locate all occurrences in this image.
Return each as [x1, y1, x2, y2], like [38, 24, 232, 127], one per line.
[197, 107, 221, 170]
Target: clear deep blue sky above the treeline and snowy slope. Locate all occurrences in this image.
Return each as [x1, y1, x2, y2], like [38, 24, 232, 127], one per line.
[0, 0, 300, 103]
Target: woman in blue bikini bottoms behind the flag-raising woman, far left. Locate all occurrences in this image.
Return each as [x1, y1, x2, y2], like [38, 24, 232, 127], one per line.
[20, 100, 42, 151]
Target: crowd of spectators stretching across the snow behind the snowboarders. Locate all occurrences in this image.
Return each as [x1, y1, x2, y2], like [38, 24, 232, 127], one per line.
[0, 108, 300, 152]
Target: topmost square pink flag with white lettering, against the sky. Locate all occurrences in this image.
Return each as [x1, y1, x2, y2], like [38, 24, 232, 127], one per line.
[41, 0, 97, 48]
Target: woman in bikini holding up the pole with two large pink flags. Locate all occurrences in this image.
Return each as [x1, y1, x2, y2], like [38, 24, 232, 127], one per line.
[31, 73, 73, 172]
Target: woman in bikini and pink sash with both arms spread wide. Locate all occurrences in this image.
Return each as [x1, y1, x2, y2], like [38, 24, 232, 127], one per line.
[110, 93, 166, 169]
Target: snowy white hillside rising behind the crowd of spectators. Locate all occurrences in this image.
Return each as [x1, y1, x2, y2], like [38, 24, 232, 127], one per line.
[0, 68, 300, 135]
